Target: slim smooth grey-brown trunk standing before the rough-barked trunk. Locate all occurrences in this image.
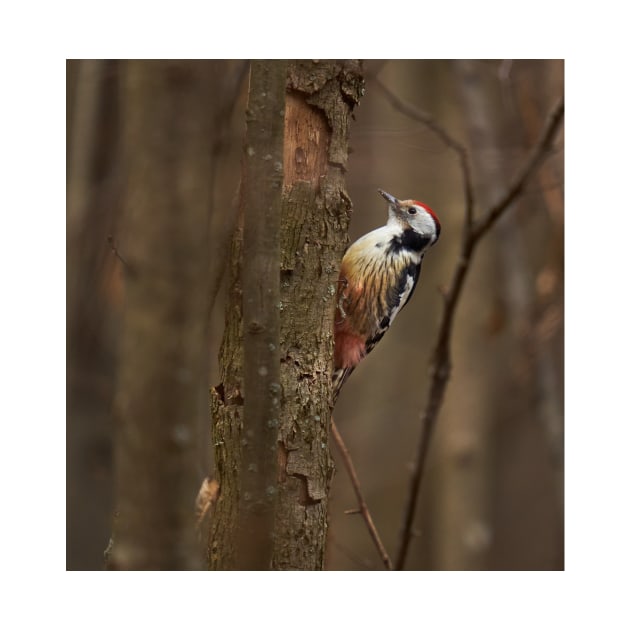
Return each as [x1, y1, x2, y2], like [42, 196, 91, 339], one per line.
[237, 61, 287, 570]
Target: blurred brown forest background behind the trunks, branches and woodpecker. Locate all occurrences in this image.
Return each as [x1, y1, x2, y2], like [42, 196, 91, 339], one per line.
[66, 60, 564, 570]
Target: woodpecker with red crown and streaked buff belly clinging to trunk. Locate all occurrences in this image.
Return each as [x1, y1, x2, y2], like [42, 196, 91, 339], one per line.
[333, 188, 441, 402]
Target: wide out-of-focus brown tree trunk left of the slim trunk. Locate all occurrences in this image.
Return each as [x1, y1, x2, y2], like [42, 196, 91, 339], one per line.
[109, 61, 213, 570]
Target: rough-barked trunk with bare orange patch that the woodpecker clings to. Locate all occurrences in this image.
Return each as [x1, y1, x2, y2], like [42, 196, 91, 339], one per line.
[209, 61, 363, 570]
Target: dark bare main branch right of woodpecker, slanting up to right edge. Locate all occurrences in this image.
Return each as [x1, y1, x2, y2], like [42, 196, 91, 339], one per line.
[395, 95, 564, 570]
